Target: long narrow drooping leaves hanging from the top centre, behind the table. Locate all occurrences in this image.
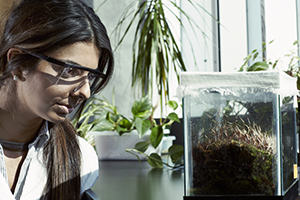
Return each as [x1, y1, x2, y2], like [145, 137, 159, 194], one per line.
[113, 0, 216, 118]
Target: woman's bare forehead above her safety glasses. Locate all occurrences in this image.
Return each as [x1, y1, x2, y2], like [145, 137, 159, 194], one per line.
[48, 42, 100, 69]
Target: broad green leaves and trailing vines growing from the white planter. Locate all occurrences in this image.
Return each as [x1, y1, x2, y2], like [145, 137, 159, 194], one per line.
[73, 96, 183, 168]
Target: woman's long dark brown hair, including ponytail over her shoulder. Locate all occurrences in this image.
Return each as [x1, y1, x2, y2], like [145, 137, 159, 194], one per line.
[0, 0, 113, 200]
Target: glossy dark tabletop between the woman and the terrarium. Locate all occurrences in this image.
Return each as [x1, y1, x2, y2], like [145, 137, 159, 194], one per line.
[92, 161, 299, 200]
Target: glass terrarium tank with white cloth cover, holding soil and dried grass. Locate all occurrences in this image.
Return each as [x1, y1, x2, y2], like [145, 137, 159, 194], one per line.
[179, 72, 298, 199]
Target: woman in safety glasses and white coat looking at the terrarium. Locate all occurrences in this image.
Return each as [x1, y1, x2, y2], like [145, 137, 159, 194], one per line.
[0, 0, 113, 200]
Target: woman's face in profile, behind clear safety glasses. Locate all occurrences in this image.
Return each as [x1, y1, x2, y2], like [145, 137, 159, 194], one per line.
[17, 42, 100, 123]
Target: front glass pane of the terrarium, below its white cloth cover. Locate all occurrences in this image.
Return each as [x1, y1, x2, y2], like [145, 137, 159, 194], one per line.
[184, 92, 278, 196]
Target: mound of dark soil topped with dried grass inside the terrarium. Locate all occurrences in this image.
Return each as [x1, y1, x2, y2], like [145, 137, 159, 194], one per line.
[192, 120, 275, 196]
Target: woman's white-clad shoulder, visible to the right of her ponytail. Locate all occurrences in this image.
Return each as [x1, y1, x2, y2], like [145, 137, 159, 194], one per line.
[78, 136, 99, 193]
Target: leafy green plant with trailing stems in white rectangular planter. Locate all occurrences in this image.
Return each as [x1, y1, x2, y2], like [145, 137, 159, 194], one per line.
[73, 96, 183, 168]
